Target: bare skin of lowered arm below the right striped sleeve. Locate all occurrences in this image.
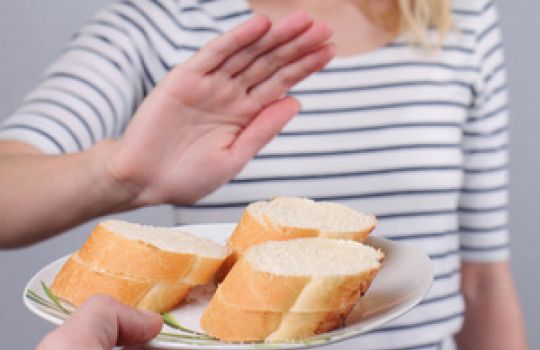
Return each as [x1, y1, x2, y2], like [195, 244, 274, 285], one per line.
[456, 262, 527, 350]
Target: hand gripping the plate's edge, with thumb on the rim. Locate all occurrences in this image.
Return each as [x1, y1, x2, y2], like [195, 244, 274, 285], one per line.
[38, 296, 162, 350]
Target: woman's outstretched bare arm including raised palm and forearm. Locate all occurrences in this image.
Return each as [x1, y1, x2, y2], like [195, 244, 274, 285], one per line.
[0, 14, 333, 247]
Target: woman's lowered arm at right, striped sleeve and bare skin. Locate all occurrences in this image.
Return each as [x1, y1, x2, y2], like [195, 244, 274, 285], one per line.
[456, 0, 527, 350]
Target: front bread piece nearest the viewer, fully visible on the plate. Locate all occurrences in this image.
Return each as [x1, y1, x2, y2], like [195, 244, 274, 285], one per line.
[201, 238, 384, 341]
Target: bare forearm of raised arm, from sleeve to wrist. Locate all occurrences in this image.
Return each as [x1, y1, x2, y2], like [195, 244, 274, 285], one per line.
[0, 141, 135, 248]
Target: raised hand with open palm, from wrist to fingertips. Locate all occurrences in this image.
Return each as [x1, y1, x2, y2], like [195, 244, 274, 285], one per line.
[109, 13, 334, 206]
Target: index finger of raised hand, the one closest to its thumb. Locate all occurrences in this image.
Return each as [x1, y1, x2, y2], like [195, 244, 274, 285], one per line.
[249, 46, 336, 106]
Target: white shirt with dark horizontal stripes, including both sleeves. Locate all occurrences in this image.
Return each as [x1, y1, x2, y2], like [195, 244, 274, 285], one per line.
[0, 0, 508, 349]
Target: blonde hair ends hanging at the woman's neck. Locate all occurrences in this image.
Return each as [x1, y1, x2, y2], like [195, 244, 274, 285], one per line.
[358, 0, 452, 46]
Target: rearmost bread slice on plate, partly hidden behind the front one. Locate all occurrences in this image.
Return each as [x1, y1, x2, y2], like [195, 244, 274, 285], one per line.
[216, 197, 377, 281]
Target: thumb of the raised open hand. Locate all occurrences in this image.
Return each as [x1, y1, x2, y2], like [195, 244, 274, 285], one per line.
[231, 97, 300, 163]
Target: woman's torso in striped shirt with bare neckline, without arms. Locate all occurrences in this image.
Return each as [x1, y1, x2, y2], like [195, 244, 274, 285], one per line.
[169, 0, 476, 349]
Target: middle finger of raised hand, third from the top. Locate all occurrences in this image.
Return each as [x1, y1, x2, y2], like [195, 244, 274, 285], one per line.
[236, 23, 332, 87]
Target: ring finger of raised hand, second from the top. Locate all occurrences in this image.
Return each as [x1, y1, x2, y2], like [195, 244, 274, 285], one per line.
[220, 12, 313, 76]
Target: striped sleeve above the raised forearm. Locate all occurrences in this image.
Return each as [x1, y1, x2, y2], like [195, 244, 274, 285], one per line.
[0, 2, 156, 154]
